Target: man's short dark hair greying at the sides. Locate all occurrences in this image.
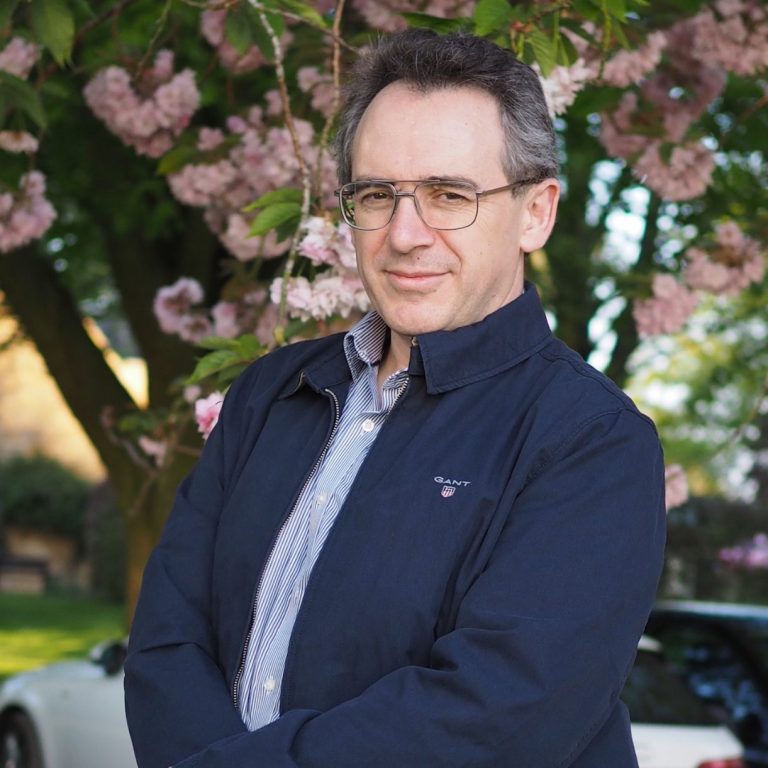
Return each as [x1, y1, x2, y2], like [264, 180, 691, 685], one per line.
[335, 29, 557, 184]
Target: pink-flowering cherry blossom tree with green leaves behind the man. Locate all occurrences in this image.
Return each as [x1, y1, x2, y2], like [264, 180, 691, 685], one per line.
[0, 0, 768, 603]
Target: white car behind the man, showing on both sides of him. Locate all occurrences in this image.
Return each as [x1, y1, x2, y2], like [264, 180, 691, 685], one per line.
[0, 638, 745, 768]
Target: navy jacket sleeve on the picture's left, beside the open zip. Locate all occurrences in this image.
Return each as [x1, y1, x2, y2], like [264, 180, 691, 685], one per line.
[125, 377, 246, 768]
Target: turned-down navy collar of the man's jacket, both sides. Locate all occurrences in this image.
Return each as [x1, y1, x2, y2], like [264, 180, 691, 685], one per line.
[284, 282, 552, 395]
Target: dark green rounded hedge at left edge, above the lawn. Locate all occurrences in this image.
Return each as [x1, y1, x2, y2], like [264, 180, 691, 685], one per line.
[0, 456, 89, 540]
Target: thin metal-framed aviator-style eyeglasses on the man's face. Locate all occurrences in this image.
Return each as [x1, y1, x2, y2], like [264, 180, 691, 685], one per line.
[336, 178, 541, 231]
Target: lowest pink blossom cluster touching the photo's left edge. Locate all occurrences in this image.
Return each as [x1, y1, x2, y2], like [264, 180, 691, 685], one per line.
[0, 171, 56, 253]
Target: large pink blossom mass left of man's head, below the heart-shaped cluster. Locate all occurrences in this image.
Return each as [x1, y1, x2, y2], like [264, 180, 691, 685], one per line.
[168, 107, 336, 261]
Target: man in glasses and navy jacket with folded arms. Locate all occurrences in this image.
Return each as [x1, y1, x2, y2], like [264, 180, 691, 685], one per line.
[126, 31, 664, 768]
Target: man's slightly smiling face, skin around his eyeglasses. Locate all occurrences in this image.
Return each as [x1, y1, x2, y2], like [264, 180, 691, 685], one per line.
[352, 83, 548, 337]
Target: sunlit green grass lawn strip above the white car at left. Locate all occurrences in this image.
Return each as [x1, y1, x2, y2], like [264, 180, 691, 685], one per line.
[0, 594, 125, 681]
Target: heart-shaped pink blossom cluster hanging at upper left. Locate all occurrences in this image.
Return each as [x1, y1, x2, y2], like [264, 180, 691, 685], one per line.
[83, 50, 200, 157]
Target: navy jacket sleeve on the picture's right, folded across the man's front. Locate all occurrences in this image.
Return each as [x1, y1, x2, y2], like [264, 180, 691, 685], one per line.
[164, 409, 665, 768]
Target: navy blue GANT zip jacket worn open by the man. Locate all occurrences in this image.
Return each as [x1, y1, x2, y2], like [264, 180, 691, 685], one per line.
[126, 286, 665, 768]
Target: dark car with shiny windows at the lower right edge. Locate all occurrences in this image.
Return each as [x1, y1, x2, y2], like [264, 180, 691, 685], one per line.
[646, 601, 768, 768]
